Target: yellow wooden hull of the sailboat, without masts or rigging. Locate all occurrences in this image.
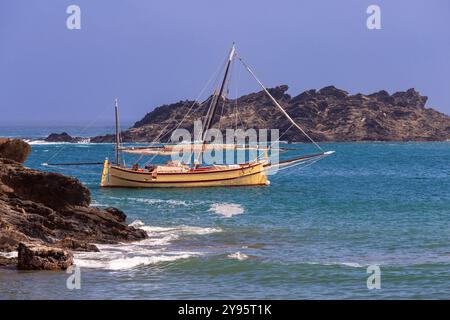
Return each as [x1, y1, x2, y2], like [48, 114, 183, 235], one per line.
[101, 162, 269, 188]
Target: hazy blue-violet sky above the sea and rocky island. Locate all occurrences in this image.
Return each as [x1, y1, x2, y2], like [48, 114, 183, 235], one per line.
[0, 0, 450, 125]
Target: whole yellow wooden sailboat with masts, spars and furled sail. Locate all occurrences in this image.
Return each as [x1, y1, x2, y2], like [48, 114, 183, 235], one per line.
[100, 45, 332, 188]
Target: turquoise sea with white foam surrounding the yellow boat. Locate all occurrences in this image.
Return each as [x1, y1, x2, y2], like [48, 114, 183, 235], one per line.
[0, 127, 450, 299]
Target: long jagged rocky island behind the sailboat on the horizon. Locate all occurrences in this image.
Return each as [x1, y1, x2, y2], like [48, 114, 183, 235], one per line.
[91, 85, 450, 142]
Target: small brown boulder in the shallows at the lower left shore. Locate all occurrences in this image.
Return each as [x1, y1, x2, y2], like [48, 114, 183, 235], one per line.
[17, 243, 73, 270]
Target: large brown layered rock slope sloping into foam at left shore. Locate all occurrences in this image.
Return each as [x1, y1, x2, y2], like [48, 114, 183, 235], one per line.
[0, 139, 147, 266]
